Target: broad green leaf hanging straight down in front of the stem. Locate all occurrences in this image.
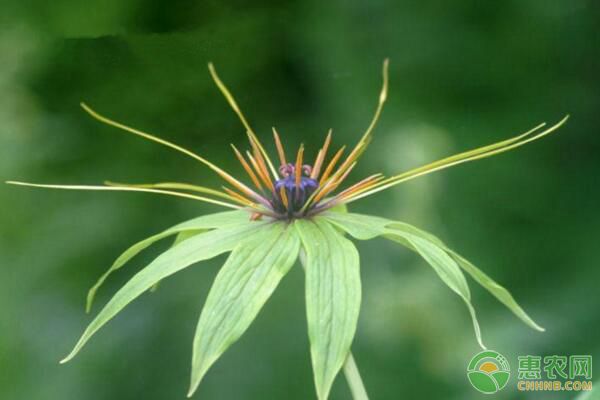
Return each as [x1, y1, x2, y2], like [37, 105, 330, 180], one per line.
[294, 218, 361, 400]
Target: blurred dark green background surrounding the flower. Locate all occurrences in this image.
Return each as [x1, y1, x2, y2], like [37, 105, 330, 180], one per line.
[0, 0, 600, 400]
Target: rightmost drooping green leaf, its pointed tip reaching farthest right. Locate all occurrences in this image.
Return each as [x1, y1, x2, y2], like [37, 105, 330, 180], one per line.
[323, 212, 544, 340]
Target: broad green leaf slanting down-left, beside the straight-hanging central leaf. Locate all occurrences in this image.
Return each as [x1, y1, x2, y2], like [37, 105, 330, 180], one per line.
[188, 222, 300, 397]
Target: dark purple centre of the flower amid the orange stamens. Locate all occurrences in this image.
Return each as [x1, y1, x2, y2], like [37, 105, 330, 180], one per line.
[273, 164, 319, 217]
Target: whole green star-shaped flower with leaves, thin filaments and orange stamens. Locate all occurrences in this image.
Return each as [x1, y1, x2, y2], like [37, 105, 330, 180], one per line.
[8, 60, 568, 399]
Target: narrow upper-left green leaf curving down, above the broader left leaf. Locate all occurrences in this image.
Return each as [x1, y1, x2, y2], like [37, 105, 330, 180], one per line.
[85, 211, 249, 313]
